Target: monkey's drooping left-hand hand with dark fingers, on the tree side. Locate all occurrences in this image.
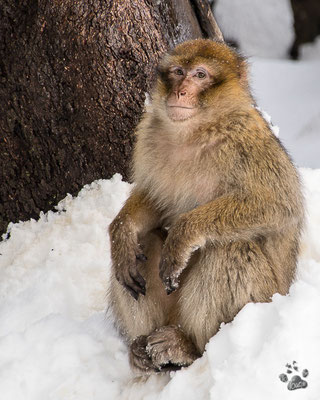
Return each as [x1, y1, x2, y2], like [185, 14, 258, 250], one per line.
[109, 220, 147, 300]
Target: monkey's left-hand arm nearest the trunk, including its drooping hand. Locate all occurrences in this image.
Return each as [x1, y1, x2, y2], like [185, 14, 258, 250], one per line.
[109, 191, 159, 299]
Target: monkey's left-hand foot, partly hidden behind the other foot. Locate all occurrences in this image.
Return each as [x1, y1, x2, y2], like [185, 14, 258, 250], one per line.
[129, 336, 156, 374]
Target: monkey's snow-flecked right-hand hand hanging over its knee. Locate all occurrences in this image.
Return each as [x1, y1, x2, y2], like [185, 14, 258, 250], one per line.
[159, 218, 202, 294]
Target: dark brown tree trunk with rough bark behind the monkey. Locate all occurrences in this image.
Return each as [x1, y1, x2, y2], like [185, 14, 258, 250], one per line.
[0, 0, 220, 233]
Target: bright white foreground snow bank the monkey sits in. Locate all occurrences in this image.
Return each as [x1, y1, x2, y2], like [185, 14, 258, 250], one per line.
[0, 169, 320, 400]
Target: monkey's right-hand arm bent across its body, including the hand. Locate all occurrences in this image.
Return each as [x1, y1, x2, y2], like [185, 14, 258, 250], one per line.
[160, 188, 300, 294]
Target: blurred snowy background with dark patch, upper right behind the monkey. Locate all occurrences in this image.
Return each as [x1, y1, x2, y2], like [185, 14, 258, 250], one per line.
[211, 0, 320, 168]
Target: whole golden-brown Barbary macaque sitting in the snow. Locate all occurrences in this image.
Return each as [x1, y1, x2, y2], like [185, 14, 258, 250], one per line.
[109, 39, 304, 374]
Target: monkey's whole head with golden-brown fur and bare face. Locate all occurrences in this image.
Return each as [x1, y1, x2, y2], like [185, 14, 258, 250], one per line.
[157, 39, 246, 122]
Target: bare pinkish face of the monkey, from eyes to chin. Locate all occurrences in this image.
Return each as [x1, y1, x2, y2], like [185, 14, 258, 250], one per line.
[166, 64, 212, 121]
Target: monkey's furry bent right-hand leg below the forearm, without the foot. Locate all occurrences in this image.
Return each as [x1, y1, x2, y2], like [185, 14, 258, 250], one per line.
[178, 241, 279, 353]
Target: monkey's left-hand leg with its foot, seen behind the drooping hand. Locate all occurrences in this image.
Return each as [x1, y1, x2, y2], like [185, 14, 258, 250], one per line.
[109, 230, 177, 372]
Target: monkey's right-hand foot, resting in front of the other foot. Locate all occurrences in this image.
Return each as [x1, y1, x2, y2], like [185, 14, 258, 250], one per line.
[146, 325, 200, 371]
